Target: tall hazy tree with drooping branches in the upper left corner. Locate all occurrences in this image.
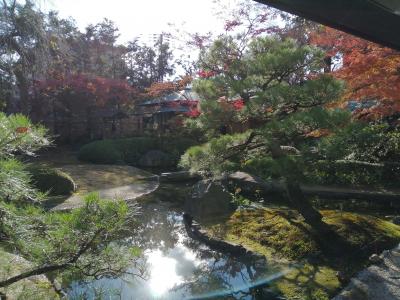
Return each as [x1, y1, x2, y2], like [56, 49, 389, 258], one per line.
[0, 0, 48, 113]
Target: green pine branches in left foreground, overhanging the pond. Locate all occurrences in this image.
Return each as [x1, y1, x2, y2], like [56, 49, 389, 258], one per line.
[0, 113, 139, 294]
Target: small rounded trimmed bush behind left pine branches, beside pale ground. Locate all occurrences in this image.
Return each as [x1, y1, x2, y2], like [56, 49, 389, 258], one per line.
[28, 166, 76, 196]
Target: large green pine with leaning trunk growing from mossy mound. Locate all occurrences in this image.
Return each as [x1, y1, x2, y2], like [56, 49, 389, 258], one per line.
[181, 37, 348, 230]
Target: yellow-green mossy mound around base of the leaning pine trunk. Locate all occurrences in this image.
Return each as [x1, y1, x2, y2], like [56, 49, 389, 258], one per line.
[205, 208, 400, 299]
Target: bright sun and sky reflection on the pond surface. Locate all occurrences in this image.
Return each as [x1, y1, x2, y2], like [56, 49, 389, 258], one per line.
[69, 198, 285, 300]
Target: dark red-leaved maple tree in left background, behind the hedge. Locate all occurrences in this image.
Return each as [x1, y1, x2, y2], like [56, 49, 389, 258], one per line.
[32, 74, 138, 137]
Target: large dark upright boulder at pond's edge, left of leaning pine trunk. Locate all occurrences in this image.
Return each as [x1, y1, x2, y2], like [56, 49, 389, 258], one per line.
[185, 180, 235, 220]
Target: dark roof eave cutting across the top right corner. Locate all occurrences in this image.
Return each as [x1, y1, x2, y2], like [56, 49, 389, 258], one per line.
[256, 0, 400, 50]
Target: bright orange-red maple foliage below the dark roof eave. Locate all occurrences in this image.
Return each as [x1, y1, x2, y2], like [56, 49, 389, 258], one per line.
[311, 27, 400, 119]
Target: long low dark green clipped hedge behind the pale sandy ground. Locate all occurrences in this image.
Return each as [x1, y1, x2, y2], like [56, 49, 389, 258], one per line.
[78, 137, 196, 166]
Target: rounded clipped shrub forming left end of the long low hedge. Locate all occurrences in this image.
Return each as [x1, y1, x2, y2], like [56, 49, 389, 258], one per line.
[78, 140, 123, 164]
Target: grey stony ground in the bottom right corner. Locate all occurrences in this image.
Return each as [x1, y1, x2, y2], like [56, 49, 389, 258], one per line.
[333, 245, 400, 300]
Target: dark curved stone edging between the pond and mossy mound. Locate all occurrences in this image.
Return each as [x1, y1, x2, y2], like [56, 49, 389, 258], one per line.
[183, 213, 266, 260]
